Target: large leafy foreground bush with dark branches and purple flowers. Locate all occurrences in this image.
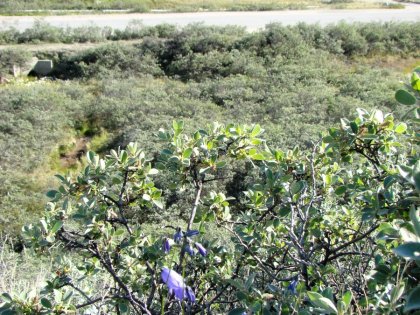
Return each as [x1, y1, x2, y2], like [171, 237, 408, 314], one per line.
[0, 72, 420, 314]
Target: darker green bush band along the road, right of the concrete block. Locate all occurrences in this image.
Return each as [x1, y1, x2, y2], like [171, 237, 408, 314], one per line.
[38, 23, 420, 81]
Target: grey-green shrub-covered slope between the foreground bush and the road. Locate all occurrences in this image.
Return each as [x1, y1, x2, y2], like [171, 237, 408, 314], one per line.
[0, 23, 420, 233]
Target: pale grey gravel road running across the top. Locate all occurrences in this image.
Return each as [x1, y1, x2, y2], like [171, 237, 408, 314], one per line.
[0, 4, 420, 31]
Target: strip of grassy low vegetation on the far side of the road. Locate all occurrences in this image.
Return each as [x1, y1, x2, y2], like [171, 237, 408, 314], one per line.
[0, 0, 406, 14]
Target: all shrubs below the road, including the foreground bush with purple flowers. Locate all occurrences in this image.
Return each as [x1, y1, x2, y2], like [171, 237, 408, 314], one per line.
[0, 23, 420, 314]
